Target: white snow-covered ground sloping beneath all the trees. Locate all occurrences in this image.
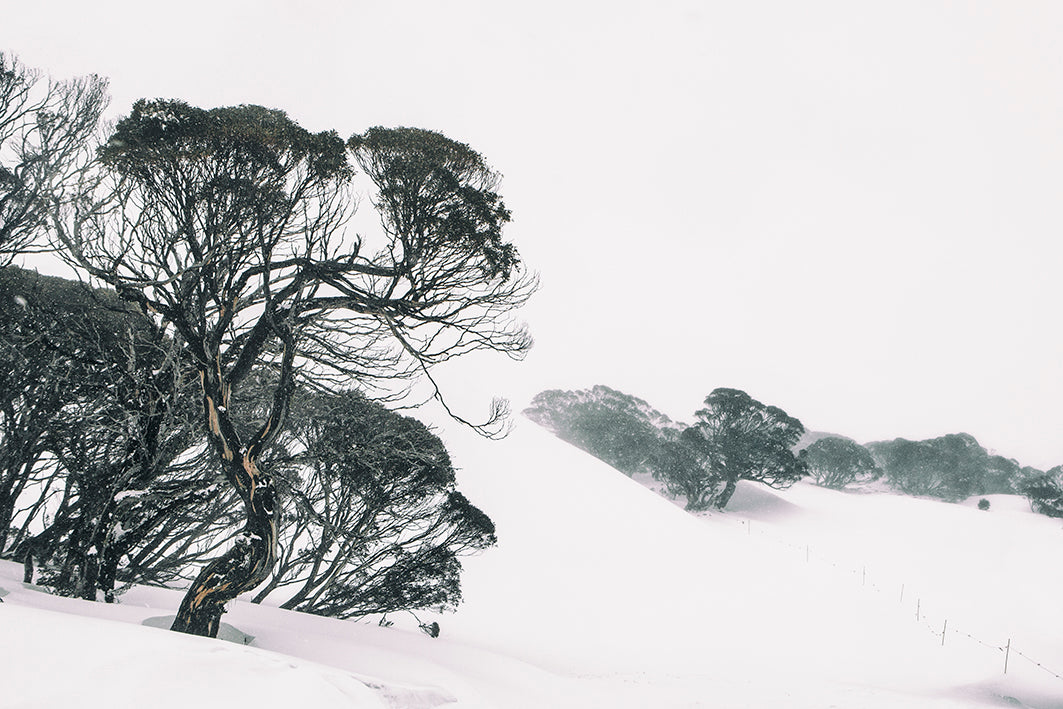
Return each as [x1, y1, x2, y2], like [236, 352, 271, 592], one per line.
[0, 420, 1063, 709]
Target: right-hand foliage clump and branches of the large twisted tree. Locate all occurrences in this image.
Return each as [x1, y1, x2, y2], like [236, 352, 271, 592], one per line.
[346, 128, 538, 416]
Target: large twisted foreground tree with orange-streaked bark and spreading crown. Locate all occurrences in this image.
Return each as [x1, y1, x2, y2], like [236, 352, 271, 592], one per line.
[57, 100, 535, 636]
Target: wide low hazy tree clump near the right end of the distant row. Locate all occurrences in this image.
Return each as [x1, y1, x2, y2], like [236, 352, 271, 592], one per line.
[867, 434, 1019, 502]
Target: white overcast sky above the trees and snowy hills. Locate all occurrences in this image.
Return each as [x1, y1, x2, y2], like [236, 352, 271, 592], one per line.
[6, 0, 1063, 468]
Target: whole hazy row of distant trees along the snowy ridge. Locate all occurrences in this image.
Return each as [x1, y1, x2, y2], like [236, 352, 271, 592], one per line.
[524, 385, 1063, 517]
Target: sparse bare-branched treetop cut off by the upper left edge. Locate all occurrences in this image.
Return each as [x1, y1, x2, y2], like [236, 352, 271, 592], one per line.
[0, 54, 108, 266]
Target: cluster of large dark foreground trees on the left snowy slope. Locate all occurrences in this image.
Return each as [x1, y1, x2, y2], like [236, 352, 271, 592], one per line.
[0, 49, 536, 636]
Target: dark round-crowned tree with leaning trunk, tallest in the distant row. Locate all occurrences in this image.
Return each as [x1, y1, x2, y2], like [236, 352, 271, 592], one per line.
[682, 389, 808, 509]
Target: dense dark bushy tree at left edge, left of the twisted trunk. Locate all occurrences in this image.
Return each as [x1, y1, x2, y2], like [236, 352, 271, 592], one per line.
[0, 267, 200, 600]
